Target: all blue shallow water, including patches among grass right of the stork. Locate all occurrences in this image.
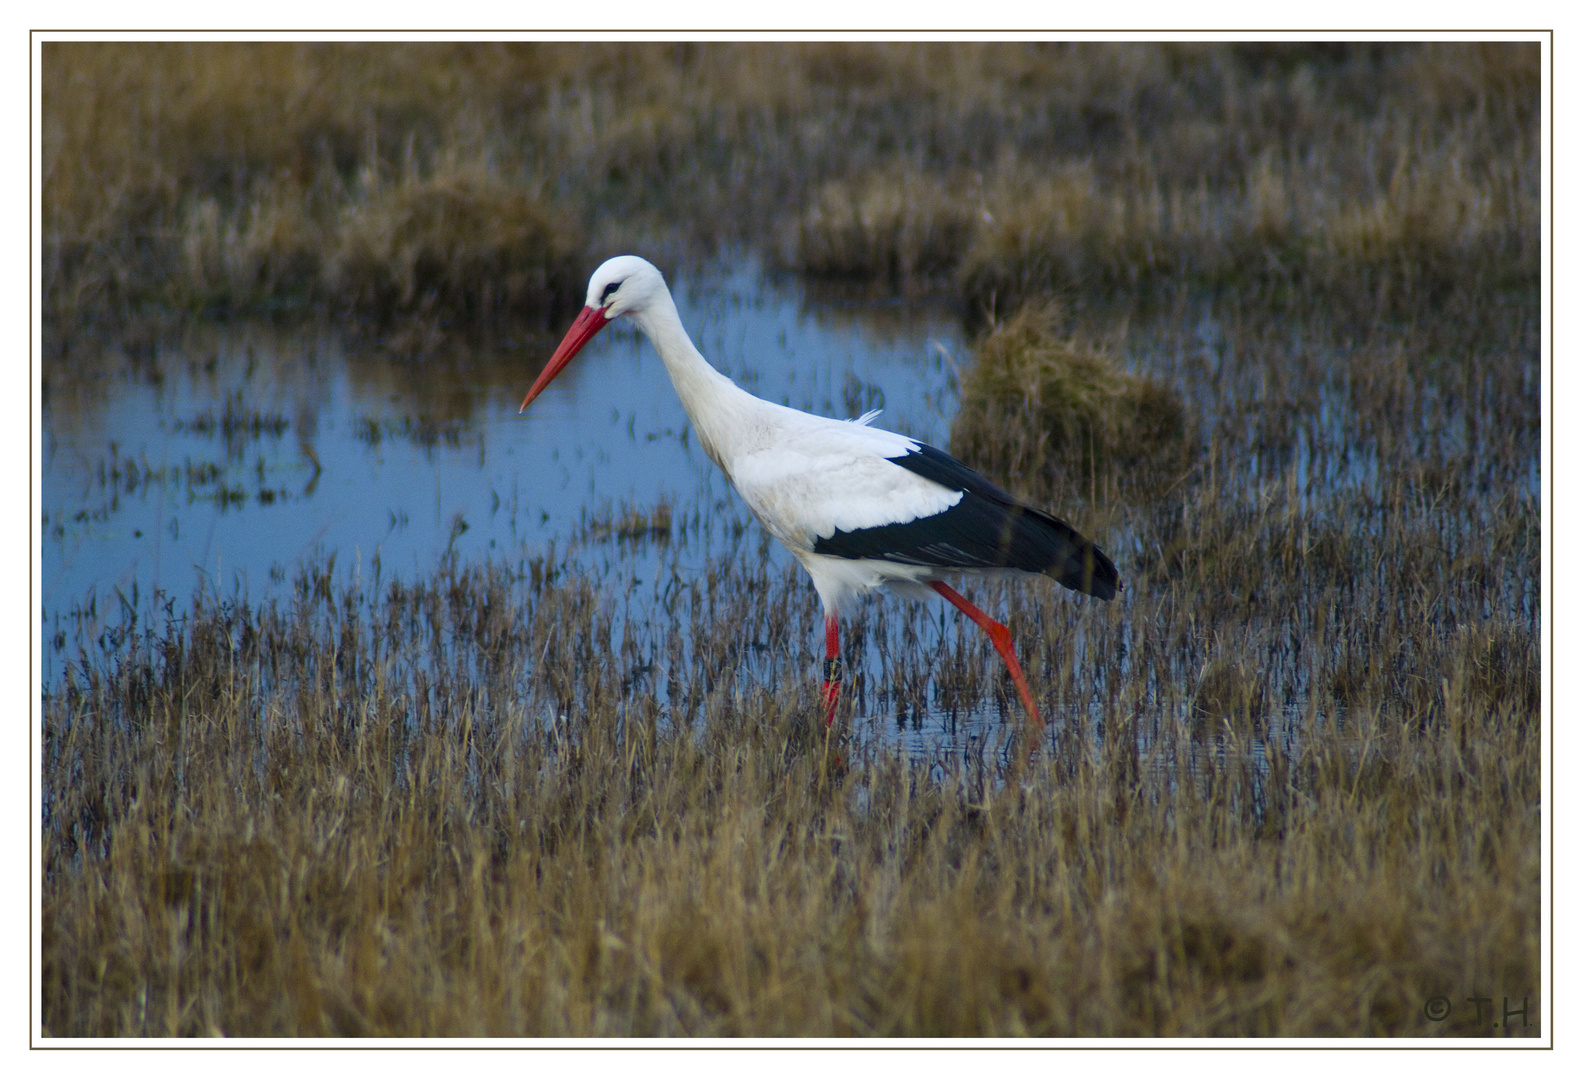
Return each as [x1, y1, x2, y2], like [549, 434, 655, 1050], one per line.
[41, 264, 1539, 765]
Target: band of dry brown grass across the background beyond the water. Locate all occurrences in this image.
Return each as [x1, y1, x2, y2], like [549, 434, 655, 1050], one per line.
[43, 43, 1539, 326]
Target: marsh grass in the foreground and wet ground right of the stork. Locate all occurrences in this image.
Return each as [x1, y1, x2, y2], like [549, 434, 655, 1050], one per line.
[43, 281, 1540, 1036]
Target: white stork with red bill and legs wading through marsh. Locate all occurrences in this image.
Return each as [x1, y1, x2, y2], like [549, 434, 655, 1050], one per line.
[522, 255, 1121, 728]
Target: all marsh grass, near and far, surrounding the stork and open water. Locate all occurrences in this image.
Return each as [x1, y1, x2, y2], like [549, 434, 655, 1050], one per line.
[41, 43, 1545, 1036]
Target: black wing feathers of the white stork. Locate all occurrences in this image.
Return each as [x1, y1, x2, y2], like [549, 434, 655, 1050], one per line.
[814, 443, 1121, 600]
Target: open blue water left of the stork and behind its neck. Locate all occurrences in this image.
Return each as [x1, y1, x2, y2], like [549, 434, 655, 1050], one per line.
[41, 258, 1063, 752]
